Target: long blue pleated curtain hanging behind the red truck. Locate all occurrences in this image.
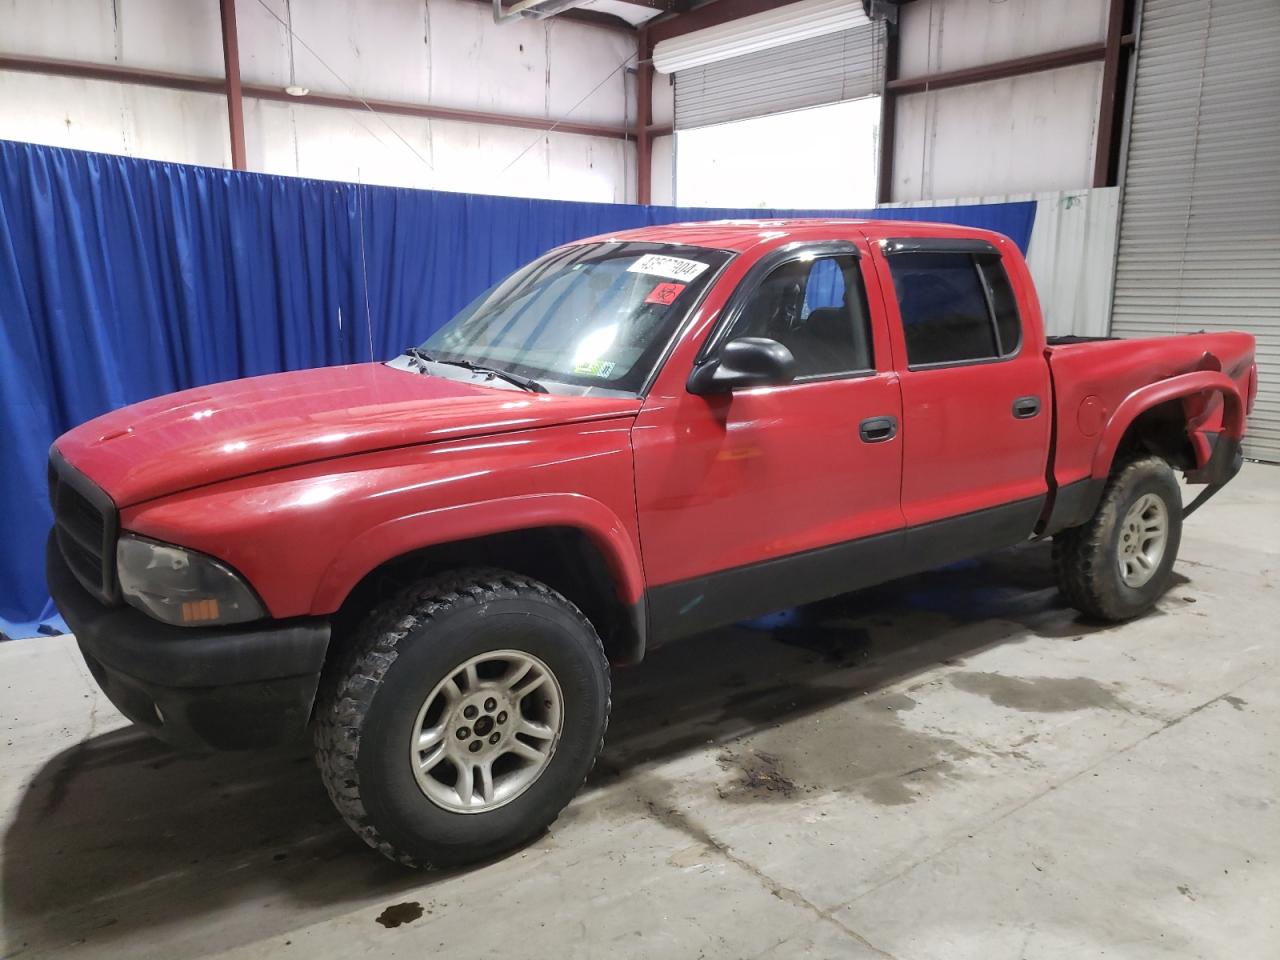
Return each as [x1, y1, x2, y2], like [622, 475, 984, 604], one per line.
[0, 141, 1036, 636]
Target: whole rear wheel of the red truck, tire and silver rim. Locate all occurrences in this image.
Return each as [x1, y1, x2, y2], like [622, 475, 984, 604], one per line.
[1053, 457, 1183, 621]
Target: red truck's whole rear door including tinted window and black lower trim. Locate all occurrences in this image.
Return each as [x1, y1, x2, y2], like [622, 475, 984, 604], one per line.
[873, 238, 1052, 568]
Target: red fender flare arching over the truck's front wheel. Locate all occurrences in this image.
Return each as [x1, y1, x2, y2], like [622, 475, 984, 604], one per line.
[311, 493, 644, 614]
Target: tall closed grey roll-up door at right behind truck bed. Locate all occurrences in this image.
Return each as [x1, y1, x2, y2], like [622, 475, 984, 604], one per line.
[1111, 0, 1280, 461]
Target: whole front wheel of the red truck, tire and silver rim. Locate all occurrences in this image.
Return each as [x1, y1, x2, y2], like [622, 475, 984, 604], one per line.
[315, 570, 609, 867]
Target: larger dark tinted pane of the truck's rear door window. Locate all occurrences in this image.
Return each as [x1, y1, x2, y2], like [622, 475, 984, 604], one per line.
[888, 253, 1000, 366]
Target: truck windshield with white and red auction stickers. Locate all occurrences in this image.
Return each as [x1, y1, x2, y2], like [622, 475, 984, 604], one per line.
[419, 242, 731, 393]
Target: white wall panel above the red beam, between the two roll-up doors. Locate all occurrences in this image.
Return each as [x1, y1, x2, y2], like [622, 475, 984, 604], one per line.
[899, 0, 1107, 77]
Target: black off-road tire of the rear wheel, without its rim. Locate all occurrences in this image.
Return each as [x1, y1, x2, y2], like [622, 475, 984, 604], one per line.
[1053, 456, 1183, 622]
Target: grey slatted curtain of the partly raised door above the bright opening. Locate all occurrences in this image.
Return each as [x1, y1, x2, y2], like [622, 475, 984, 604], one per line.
[675, 20, 884, 129]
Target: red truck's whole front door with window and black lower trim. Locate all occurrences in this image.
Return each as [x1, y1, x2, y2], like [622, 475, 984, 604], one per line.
[632, 243, 904, 641]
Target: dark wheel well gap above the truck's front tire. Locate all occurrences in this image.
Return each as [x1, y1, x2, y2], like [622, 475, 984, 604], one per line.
[328, 526, 643, 663]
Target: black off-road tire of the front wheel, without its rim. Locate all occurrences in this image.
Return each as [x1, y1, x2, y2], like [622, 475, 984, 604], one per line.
[314, 570, 611, 869]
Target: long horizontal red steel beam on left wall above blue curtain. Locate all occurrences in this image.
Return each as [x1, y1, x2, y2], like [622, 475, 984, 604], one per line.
[0, 55, 635, 140]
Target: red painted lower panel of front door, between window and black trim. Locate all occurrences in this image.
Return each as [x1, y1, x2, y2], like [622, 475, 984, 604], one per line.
[632, 372, 904, 585]
